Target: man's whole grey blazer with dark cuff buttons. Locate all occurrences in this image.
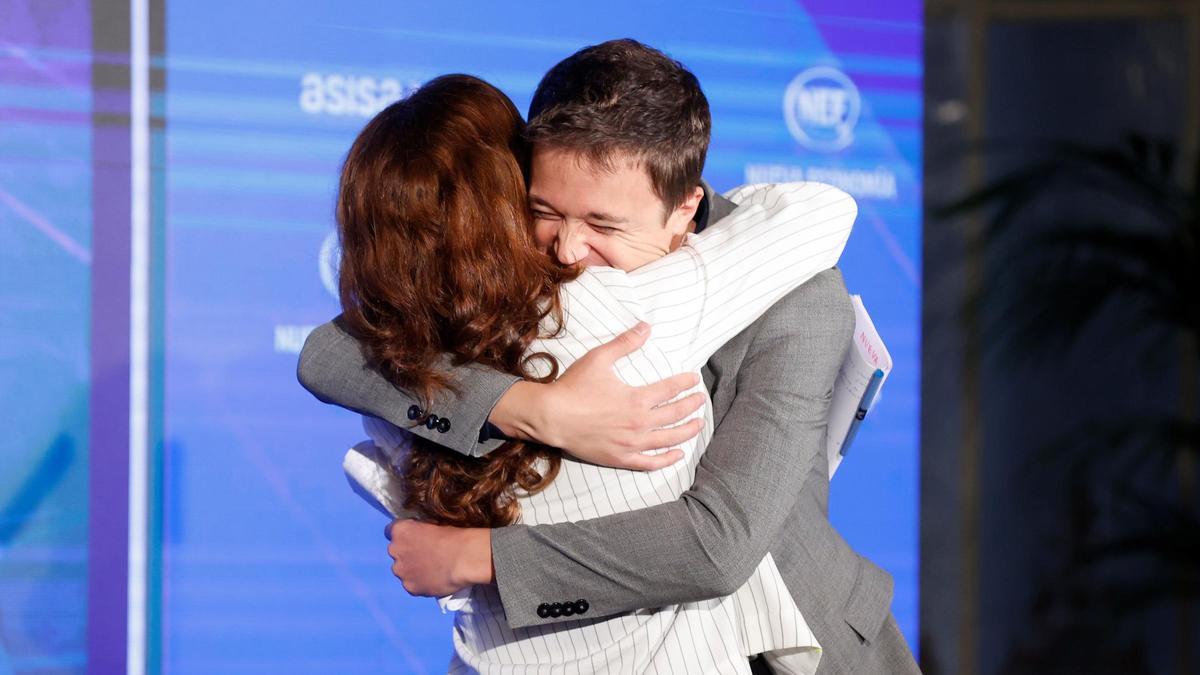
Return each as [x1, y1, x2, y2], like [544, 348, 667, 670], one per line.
[299, 186, 919, 675]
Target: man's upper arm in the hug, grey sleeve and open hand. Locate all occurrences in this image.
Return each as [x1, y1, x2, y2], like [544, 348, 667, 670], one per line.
[296, 317, 704, 461]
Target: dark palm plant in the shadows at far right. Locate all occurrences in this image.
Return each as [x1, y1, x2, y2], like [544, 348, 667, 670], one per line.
[932, 135, 1200, 674]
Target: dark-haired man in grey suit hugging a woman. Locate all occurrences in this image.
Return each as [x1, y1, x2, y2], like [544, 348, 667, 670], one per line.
[299, 40, 918, 674]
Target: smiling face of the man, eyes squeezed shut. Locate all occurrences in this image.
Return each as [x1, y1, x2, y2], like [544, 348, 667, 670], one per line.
[529, 147, 703, 271]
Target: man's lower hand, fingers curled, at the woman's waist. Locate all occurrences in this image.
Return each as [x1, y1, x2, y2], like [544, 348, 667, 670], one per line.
[384, 519, 494, 597]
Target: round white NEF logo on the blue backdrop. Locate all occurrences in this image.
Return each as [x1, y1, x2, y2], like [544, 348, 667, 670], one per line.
[784, 66, 863, 153]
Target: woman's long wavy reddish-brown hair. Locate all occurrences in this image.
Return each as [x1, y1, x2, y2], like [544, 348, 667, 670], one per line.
[337, 74, 576, 527]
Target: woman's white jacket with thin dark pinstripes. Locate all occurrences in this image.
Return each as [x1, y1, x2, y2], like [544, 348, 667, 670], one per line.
[366, 183, 857, 675]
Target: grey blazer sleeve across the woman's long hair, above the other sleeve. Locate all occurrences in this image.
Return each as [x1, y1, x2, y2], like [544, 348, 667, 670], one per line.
[296, 317, 520, 456]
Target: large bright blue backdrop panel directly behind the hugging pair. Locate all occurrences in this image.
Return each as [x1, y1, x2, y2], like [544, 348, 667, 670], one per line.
[159, 0, 922, 674]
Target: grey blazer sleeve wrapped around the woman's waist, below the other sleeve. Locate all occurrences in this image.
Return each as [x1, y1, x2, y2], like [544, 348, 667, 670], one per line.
[492, 270, 854, 628]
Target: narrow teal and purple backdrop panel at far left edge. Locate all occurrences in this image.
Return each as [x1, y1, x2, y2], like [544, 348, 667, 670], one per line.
[0, 0, 93, 675]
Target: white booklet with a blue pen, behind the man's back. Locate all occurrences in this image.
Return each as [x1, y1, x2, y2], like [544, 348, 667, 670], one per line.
[826, 295, 892, 479]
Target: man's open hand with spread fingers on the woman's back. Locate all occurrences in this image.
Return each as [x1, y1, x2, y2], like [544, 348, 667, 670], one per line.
[488, 322, 704, 471]
